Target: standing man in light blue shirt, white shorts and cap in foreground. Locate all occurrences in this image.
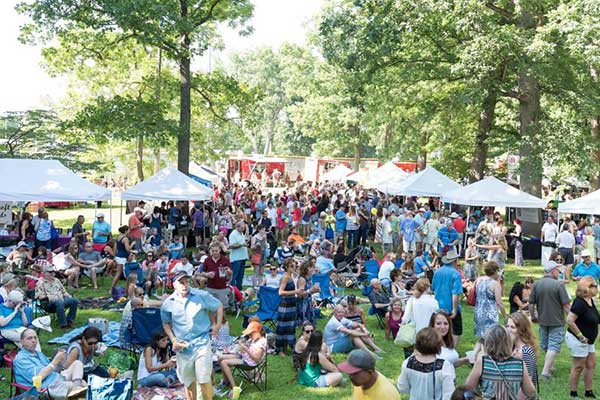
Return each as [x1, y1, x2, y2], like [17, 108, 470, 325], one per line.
[160, 271, 223, 399]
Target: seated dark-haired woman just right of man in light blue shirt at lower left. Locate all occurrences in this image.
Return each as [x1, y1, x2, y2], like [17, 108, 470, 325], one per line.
[65, 326, 109, 380]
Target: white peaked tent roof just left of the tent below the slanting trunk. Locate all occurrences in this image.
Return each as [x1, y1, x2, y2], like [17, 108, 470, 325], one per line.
[377, 167, 460, 197]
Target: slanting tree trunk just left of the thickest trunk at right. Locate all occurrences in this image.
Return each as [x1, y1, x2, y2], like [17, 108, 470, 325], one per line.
[469, 85, 498, 183]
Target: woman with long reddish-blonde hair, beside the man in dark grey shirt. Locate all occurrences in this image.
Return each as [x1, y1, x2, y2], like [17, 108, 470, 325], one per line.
[506, 311, 538, 396]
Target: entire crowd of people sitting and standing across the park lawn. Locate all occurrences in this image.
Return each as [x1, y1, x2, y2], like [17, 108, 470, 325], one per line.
[0, 182, 600, 400]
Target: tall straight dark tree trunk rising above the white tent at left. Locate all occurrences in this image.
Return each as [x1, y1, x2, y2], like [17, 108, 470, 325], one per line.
[177, 0, 192, 174]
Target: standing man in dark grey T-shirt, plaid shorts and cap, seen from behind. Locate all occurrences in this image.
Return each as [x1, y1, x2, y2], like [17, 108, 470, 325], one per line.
[529, 261, 570, 380]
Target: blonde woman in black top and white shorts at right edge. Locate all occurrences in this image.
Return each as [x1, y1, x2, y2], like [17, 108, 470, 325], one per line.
[565, 276, 600, 398]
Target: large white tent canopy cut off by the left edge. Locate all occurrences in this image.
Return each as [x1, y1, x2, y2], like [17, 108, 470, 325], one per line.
[0, 158, 111, 201]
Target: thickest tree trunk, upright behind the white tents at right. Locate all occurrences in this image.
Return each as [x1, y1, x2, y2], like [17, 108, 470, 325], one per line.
[519, 72, 542, 197]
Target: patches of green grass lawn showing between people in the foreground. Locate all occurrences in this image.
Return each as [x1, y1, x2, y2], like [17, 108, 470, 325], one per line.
[0, 261, 600, 400]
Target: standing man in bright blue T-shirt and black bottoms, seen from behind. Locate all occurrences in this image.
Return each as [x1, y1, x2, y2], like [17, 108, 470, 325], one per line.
[431, 250, 463, 346]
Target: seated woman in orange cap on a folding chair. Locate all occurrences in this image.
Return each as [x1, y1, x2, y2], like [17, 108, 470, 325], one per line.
[215, 321, 267, 396]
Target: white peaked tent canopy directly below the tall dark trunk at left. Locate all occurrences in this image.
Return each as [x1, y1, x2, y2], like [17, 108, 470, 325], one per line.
[121, 168, 213, 201]
